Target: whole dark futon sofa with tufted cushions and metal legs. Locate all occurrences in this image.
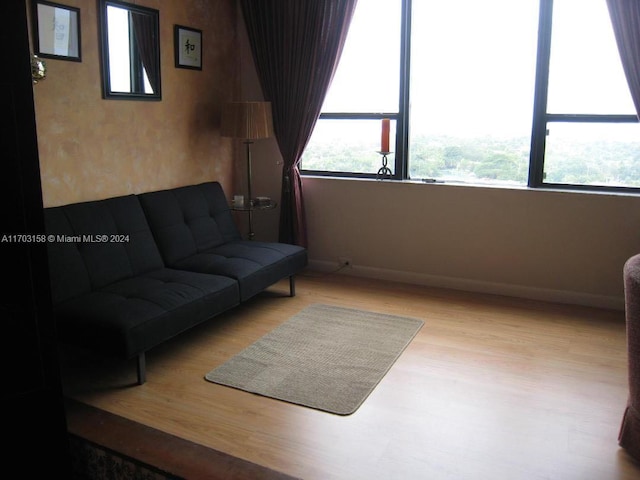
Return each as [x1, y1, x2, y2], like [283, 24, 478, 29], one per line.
[45, 182, 307, 384]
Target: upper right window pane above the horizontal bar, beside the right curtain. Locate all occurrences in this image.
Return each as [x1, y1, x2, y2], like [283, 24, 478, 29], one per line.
[547, 0, 635, 115]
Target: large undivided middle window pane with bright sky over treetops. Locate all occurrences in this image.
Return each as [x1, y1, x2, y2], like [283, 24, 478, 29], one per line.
[409, 0, 539, 184]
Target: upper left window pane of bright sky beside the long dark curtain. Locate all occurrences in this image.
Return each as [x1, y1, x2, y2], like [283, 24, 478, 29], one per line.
[322, 0, 402, 113]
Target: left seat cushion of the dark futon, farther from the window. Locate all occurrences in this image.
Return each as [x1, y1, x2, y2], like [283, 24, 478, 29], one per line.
[54, 268, 239, 358]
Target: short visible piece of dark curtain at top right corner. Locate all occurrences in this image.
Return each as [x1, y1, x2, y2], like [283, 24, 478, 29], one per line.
[607, 0, 640, 116]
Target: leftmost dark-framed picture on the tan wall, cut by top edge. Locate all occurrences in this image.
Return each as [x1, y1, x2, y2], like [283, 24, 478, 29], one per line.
[31, 0, 82, 62]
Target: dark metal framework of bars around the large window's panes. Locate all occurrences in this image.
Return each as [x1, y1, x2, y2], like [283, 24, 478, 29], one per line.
[301, 0, 640, 193]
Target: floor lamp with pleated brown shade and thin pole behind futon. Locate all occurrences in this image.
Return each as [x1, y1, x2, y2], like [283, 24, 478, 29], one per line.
[221, 102, 273, 240]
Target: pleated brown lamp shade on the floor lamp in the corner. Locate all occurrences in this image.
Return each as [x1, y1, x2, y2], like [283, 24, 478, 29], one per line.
[221, 102, 273, 140]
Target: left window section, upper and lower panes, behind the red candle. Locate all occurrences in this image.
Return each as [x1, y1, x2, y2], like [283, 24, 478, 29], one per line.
[303, 0, 402, 175]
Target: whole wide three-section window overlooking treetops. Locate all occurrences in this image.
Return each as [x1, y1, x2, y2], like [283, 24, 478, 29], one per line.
[301, 0, 640, 189]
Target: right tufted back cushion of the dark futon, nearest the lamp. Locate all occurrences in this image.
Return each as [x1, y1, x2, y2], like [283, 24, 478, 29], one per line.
[139, 182, 240, 266]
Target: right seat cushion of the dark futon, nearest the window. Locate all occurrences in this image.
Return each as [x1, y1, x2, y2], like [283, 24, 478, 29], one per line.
[173, 240, 307, 301]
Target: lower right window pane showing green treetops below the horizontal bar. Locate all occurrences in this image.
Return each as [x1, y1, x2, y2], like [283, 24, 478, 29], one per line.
[544, 123, 640, 187]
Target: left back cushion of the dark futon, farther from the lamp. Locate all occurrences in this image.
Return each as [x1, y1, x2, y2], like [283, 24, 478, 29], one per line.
[44, 195, 164, 304]
